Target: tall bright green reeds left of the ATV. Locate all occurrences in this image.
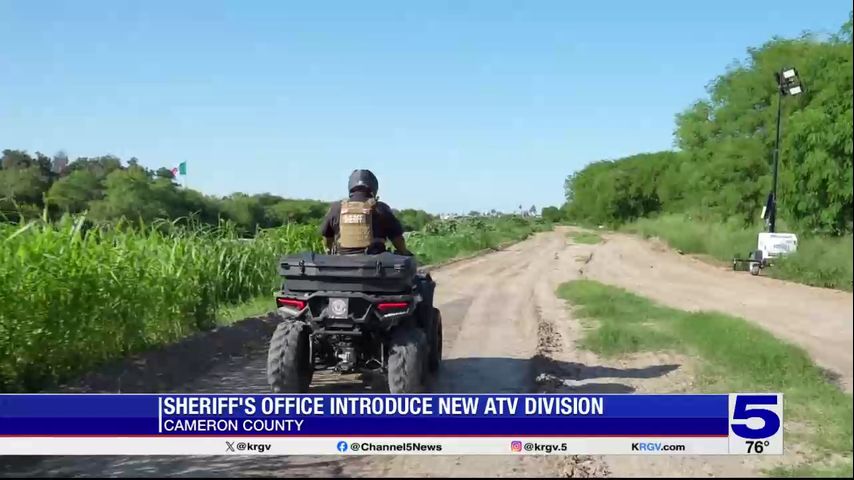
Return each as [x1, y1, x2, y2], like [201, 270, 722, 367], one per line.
[0, 216, 320, 390]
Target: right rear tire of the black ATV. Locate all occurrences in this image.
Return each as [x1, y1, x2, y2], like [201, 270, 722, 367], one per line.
[388, 326, 428, 393]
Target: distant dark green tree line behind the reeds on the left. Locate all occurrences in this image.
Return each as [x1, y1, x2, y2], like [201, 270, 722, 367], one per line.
[0, 149, 435, 235]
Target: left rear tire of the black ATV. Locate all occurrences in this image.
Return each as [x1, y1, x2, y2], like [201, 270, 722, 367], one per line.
[267, 320, 314, 393]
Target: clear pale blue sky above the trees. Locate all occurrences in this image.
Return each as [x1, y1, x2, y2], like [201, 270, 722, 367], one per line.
[0, 0, 851, 212]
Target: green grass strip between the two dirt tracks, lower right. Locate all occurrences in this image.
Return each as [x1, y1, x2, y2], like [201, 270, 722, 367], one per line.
[558, 280, 854, 477]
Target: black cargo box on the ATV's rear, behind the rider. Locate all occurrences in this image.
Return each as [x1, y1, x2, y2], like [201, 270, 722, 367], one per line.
[279, 252, 417, 293]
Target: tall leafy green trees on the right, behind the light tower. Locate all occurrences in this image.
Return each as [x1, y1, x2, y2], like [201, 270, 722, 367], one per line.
[564, 13, 854, 235]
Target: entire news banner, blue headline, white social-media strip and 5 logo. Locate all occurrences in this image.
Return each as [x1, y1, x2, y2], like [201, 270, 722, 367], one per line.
[0, 393, 783, 456]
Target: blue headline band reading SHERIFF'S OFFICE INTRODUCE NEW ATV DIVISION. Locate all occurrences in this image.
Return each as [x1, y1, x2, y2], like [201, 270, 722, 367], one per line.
[0, 394, 736, 438]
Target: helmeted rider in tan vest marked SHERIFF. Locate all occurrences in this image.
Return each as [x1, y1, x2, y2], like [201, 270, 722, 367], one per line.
[320, 170, 412, 255]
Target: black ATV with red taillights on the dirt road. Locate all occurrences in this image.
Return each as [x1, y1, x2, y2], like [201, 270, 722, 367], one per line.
[267, 252, 442, 393]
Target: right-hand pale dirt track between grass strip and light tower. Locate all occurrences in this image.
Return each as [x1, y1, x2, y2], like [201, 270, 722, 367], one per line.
[584, 235, 854, 392]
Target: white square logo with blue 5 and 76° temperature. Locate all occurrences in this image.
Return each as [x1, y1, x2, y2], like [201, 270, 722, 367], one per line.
[729, 393, 783, 455]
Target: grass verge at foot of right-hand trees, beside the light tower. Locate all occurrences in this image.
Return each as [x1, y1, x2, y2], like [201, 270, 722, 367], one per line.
[622, 215, 854, 291]
